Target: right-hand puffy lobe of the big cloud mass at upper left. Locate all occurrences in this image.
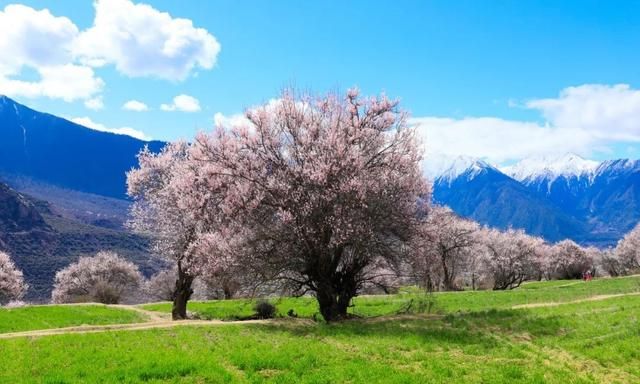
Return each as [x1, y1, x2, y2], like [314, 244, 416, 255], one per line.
[74, 0, 220, 80]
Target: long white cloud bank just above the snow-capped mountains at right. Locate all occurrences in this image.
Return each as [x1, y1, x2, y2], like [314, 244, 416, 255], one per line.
[418, 85, 640, 164]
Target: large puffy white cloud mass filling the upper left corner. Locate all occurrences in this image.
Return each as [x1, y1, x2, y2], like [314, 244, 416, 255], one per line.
[0, 0, 220, 105]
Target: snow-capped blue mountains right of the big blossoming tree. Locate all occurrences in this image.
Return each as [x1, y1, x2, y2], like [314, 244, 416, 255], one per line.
[427, 154, 640, 247]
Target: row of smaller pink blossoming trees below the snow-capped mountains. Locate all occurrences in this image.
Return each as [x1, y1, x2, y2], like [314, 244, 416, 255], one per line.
[407, 207, 640, 290]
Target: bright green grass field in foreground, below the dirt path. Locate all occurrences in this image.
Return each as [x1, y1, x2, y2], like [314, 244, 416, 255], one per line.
[0, 277, 640, 383]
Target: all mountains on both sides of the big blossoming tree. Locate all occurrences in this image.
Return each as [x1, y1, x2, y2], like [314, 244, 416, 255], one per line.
[0, 96, 640, 299]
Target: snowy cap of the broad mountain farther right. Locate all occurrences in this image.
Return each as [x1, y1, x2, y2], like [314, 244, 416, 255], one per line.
[502, 153, 600, 182]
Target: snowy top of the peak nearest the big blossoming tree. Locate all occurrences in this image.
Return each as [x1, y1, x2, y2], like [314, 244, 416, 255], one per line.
[423, 154, 493, 182]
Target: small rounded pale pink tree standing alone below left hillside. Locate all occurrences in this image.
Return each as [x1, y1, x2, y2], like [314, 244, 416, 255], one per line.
[51, 251, 142, 304]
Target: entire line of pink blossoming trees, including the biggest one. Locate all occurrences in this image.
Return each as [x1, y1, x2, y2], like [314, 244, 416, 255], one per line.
[0, 91, 640, 321]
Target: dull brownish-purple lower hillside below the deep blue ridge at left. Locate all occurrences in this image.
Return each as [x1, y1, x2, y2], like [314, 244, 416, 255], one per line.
[0, 183, 162, 301]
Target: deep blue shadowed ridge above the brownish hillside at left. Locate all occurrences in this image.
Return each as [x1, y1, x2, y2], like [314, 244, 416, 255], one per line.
[0, 96, 164, 199]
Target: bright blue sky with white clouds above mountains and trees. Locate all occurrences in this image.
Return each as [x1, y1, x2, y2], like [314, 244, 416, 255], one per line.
[0, 0, 640, 164]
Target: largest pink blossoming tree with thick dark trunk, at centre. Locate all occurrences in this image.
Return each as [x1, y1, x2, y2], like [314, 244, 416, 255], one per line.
[129, 91, 429, 321]
